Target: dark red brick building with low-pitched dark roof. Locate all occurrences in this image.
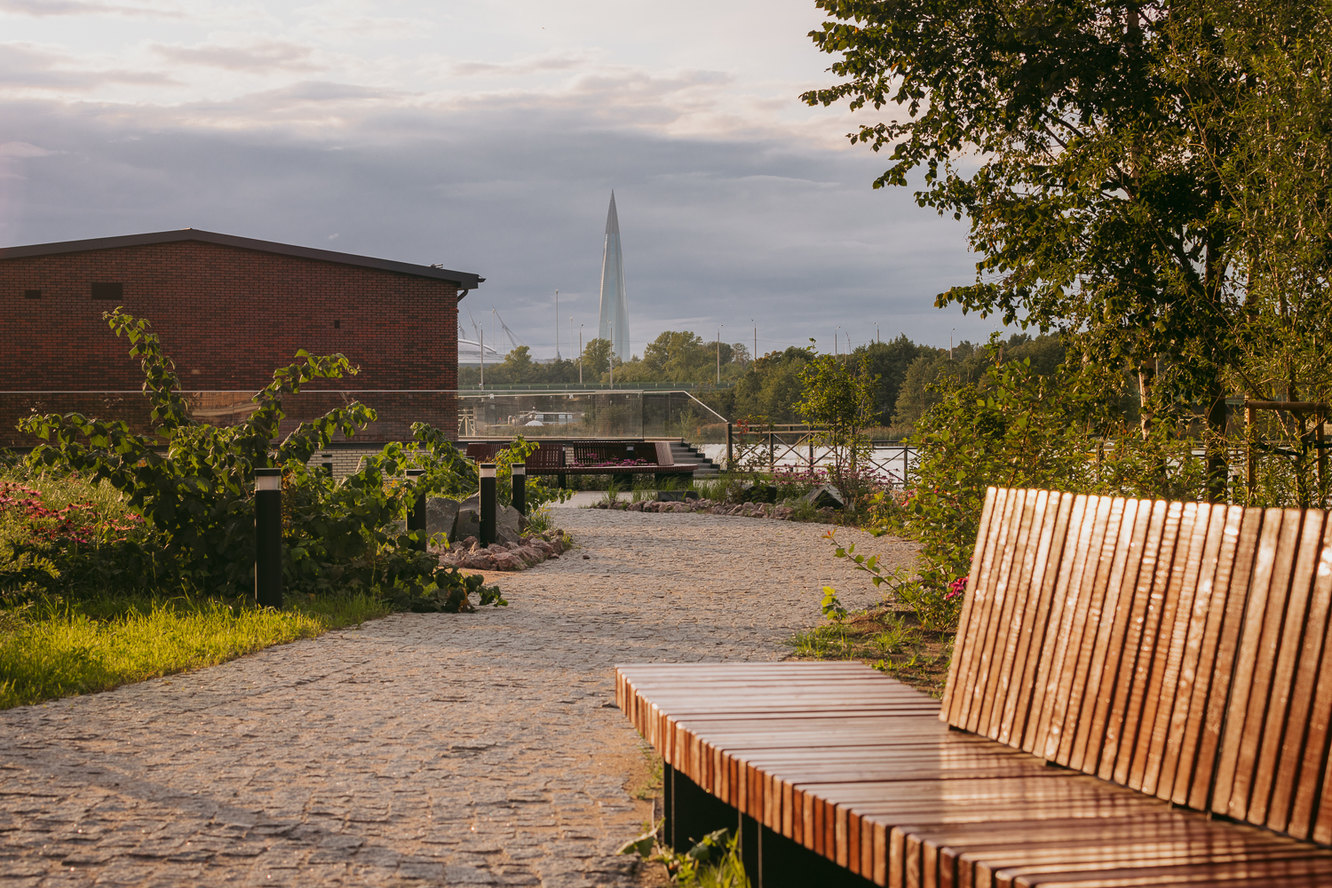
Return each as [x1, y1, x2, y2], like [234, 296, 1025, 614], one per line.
[0, 229, 485, 446]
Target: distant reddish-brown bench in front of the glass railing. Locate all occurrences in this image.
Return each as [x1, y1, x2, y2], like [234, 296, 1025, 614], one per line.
[466, 441, 697, 487]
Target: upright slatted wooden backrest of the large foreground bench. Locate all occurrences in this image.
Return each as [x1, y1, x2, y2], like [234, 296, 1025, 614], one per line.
[942, 489, 1332, 844]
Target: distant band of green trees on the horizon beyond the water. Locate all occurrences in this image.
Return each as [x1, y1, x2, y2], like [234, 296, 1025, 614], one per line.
[458, 330, 1064, 434]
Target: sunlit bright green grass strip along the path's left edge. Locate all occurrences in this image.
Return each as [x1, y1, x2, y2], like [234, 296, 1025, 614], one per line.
[0, 596, 388, 708]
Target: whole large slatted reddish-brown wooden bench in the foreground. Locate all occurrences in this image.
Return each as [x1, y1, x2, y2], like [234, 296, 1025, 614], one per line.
[617, 490, 1332, 888]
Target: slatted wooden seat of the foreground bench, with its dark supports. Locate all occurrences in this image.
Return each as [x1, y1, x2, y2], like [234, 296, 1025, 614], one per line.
[617, 662, 1332, 888]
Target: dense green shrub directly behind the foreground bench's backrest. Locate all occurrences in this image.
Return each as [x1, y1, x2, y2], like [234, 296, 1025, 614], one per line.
[879, 351, 1203, 620]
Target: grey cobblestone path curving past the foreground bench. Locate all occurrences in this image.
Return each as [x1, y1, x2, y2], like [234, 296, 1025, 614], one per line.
[0, 507, 911, 888]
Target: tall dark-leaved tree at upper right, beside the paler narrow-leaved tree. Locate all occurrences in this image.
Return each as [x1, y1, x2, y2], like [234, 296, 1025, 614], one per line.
[805, 0, 1245, 498]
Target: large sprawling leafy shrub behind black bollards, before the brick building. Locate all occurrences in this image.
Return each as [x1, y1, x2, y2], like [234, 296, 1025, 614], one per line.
[12, 309, 503, 610]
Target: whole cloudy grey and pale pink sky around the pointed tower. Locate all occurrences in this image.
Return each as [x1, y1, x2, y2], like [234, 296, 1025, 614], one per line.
[0, 0, 998, 358]
